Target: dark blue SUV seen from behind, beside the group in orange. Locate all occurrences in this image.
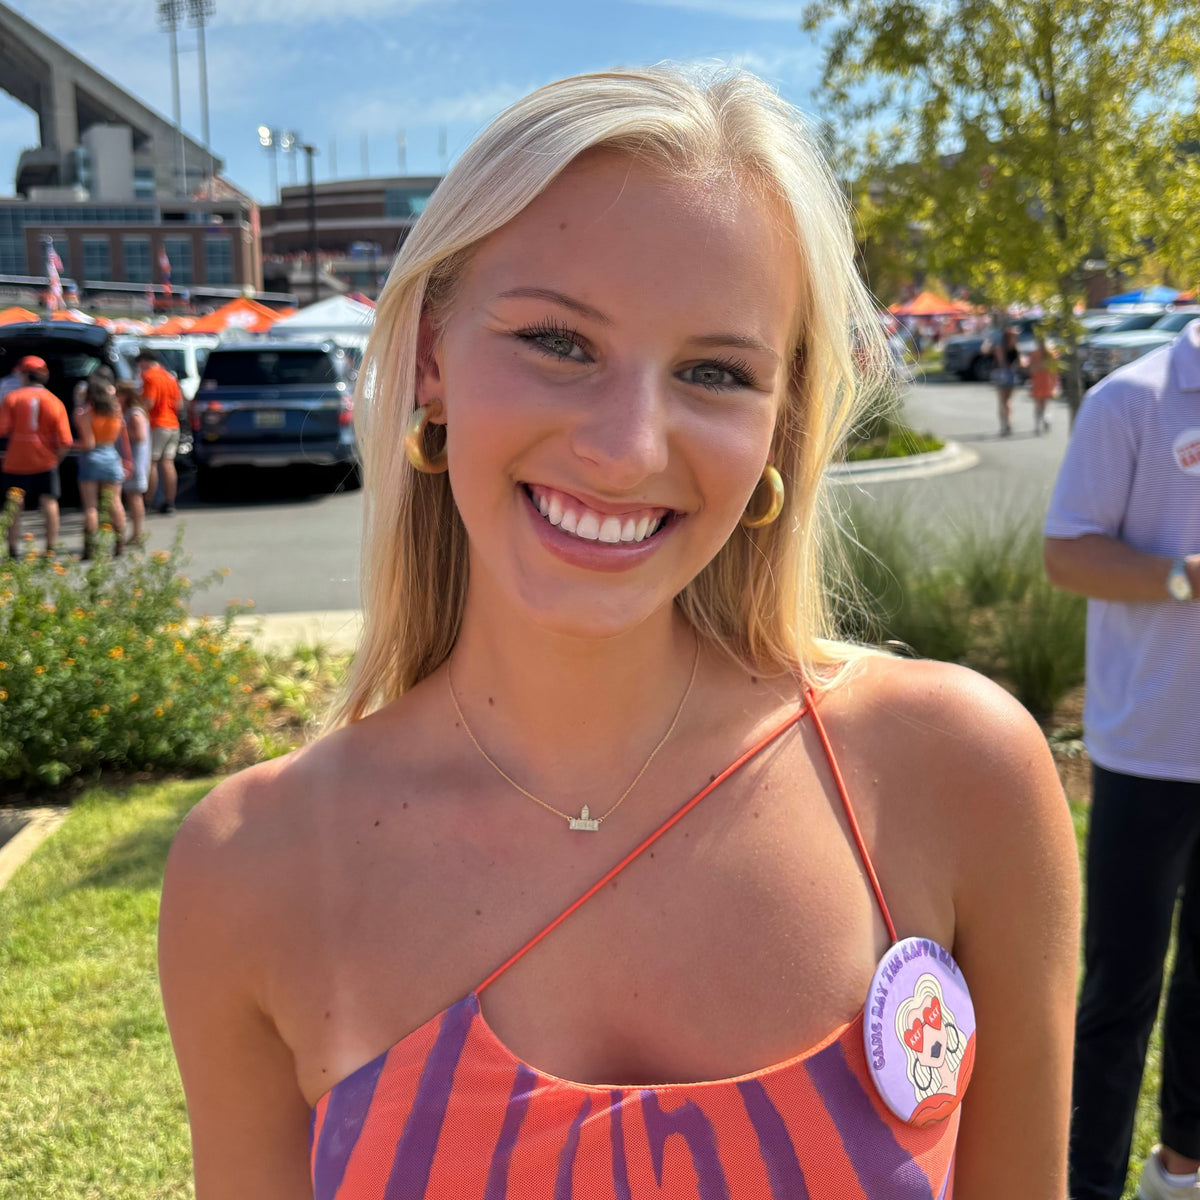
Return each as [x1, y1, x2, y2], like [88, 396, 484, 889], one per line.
[191, 341, 361, 499]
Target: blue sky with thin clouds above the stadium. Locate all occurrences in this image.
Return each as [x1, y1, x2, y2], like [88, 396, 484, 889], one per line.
[0, 0, 820, 200]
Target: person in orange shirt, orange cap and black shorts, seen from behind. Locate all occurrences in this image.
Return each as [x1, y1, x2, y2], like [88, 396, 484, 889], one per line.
[0, 355, 71, 554]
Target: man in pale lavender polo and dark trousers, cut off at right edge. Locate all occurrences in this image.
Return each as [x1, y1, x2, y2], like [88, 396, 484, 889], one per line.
[1045, 320, 1200, 1200]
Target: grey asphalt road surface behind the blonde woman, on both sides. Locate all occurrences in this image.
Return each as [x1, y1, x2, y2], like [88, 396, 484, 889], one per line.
[42, 380, 1067, 614]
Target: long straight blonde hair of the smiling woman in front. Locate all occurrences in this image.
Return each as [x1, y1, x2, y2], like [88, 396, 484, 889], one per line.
[335, 67, 890, 724]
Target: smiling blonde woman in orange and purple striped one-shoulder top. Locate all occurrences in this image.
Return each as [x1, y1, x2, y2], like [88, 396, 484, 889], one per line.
[161, 70, 1079, 1200]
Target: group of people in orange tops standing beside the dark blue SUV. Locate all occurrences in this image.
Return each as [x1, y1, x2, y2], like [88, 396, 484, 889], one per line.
[0, 350, 182, 560]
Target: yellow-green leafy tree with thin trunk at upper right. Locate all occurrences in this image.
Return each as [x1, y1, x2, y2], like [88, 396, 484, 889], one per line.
[802, 0, 1200, 403]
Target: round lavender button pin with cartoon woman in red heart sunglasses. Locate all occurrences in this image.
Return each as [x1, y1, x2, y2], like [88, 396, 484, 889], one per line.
[863, 937, 976, 1128]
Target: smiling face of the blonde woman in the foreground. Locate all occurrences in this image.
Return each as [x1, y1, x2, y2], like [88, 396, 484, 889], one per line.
[418, 152, 800, 636]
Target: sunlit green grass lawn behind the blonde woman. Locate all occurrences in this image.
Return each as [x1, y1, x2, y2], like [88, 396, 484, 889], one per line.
[0, 780, 1159, 1200]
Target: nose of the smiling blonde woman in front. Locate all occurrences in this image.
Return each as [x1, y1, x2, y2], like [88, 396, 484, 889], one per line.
[571, 370, 670, 491]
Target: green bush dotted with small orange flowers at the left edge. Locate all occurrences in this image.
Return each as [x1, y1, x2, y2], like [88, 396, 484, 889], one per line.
[0, 482, 259, 794]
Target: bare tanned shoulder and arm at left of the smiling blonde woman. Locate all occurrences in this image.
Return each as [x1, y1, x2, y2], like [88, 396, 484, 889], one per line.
[158, 705, 434, 1200]
